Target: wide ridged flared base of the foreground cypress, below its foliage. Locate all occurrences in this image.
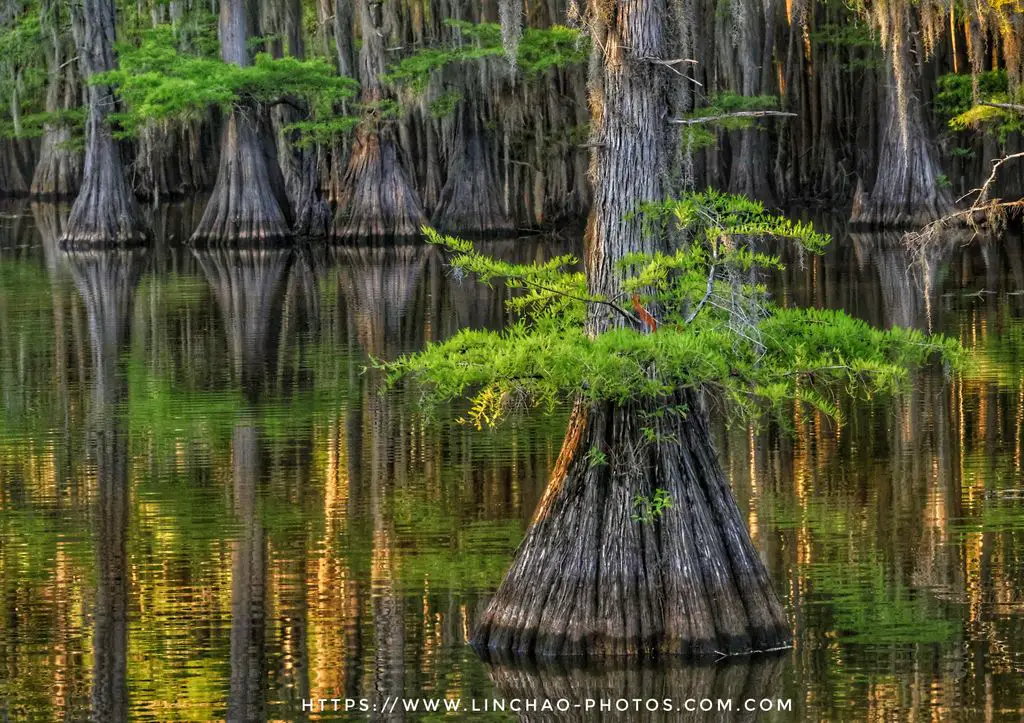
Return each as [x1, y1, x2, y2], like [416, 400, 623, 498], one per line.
[473, 397, 792, 658]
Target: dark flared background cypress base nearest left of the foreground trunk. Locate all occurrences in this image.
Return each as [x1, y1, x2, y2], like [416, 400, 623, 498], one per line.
[432, 101, 516, 235]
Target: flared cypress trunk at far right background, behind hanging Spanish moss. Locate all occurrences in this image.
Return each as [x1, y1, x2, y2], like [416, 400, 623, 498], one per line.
[850, 0, 953, 227]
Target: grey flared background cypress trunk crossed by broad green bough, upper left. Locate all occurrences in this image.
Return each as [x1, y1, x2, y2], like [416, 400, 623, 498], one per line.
[191, 0, 292, 244]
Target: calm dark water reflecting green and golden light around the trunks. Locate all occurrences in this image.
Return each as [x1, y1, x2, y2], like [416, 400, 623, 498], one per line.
[0, 199, 1024, 721]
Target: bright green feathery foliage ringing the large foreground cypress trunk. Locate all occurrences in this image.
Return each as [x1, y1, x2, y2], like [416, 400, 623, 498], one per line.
[377, 192, 963, 428]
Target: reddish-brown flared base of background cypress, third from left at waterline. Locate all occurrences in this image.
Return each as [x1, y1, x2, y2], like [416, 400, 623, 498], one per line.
[331, 131, 427, 240]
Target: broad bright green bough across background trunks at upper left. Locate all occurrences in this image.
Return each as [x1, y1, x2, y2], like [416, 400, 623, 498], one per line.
[91, 26, 356, 134]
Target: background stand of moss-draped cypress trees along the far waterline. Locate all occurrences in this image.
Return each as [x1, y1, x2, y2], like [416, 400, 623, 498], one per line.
[0, 0, 1024, 240]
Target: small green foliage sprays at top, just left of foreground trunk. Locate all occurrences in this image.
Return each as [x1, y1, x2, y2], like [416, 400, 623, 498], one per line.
[386, 20, 590, 91]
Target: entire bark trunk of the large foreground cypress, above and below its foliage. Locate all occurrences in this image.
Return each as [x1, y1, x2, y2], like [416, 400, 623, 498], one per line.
[474, 0, 791, 657]
